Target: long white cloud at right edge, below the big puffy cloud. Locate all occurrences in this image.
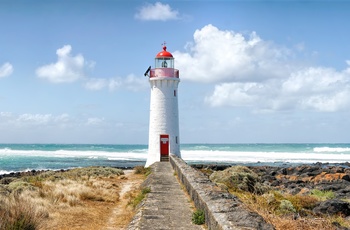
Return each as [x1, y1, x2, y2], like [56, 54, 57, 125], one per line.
[205, 67, 350, 112]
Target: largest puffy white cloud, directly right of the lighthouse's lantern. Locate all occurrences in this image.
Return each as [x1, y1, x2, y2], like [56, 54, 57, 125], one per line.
[173, 24, 291, 82]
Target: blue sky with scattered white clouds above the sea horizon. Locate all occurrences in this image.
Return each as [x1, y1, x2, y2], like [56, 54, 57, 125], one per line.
[0, 0, 350, 144]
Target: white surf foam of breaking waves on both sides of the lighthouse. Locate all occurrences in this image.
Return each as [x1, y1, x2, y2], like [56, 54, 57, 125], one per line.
[0, 146, 350, 164]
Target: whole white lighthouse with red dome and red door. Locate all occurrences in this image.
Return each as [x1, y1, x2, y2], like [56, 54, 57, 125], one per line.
[145, 43, 181, 167]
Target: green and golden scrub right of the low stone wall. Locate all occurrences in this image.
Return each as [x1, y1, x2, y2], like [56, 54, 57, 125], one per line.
[207, 167, 350, 230]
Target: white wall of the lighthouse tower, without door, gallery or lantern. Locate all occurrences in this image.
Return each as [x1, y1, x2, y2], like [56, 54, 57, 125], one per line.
[145, 77, 181, 167]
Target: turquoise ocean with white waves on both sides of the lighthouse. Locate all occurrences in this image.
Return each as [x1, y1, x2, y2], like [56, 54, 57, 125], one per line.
[0, 144, 350, 174]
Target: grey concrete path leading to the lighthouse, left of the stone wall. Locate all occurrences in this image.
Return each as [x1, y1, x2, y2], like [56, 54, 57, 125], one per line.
[129, 162, 203, 230]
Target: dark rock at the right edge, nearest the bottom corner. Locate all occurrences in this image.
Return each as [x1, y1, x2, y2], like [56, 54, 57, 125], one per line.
[313, 199, 350, 216]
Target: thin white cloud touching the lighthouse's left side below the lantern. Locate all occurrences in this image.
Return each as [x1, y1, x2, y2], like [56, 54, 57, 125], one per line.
[85, 74, 148, 91]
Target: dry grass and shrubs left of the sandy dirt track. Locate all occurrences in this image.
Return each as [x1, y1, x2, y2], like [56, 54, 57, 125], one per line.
[0, 167, 124, 230]
